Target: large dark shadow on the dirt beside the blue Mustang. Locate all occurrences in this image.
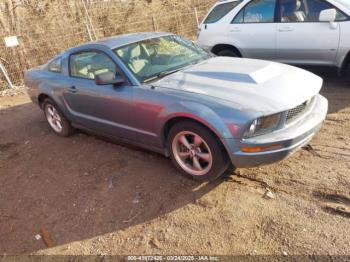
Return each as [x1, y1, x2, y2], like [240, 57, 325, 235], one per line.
[0, 104, 223, 254]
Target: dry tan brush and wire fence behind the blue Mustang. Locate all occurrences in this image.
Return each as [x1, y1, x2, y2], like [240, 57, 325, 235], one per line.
[0, 0, 215, 88]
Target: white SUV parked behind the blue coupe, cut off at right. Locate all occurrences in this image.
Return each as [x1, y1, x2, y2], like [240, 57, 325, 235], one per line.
[198, 0, 350, 72]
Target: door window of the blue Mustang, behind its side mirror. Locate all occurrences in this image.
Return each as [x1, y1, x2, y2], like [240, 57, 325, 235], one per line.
[69, 51, 117, 80]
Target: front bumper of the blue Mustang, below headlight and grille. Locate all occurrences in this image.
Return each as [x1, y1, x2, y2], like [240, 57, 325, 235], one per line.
[226, 95, 328, 168]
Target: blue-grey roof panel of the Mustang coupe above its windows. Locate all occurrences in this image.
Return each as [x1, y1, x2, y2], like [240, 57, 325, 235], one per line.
[79, 32, 172, 49]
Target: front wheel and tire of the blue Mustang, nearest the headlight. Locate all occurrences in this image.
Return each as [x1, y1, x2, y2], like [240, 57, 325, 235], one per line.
[167, 121, 230, 182]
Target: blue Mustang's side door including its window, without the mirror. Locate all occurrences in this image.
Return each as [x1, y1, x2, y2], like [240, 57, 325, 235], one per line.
[63, 50, 134, 139]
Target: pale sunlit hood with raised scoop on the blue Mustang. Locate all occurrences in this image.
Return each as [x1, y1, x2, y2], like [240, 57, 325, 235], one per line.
[154, 57, 323, 114]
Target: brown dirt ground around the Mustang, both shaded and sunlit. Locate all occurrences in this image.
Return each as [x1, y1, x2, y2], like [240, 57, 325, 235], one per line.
[0, 68, 350, 255]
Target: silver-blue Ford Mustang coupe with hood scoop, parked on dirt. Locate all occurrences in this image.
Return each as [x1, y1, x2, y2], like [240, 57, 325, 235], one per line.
[25, 33, 328, 181]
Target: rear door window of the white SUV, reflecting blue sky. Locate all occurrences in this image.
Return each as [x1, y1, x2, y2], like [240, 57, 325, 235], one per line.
[232, 0, 276, 24]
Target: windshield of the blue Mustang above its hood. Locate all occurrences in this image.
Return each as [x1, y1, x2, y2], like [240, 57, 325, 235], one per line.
[114, 35, 210, 83]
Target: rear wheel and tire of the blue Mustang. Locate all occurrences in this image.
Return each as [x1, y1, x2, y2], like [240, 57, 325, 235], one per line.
[43, 98, 74, 137]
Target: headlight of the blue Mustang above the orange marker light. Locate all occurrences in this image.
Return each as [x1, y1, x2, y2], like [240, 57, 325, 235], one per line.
[244, 113, 281, 138]
